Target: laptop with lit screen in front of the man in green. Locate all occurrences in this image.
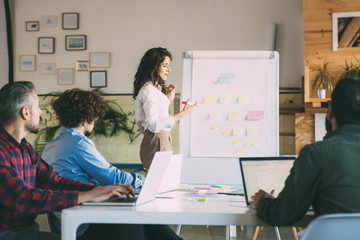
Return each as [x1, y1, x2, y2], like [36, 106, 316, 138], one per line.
[239, 157, 296, 206]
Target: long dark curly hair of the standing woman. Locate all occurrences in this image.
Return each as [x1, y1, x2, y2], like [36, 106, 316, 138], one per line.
[133, 47, 172, 99]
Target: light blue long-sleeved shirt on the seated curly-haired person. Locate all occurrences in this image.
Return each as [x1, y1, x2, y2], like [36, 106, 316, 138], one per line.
[42, 127, 145, 189]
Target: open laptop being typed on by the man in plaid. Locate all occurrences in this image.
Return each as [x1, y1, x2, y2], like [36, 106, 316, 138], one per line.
[83, 151, 173, 206]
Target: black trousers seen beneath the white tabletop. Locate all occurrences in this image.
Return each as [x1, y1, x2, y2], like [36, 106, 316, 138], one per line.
[78, 224, 182, 240]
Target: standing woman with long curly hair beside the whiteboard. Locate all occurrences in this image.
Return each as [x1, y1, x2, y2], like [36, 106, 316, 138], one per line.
[133, 47, 198, 169]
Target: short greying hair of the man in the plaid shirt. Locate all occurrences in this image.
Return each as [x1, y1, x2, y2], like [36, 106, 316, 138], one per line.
[0, 81, 36, 125]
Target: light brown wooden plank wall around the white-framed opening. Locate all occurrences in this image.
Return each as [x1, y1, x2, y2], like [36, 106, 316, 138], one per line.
[303, 0, 360, 102]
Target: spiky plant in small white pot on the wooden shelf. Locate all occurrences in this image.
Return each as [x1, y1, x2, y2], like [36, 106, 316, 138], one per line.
[312, 60, 334, 98]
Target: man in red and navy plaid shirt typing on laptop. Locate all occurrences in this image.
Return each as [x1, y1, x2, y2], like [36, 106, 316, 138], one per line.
[0, 81, 134, 240]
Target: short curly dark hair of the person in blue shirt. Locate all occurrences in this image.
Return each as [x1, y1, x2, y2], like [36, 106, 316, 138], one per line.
[52, 88, 108, 128]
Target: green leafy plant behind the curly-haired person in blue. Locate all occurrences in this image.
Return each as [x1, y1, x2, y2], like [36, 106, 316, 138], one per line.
[34, 89, 141, 154]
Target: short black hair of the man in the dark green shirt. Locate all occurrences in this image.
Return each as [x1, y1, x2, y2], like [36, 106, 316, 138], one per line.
[331, 76, 360, 126]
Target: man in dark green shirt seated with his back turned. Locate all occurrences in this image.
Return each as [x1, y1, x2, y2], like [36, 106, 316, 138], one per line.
[251, 78, 360, 226]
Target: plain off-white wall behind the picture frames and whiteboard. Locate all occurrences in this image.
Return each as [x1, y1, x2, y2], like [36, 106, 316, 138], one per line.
[14, 0, 303, 93]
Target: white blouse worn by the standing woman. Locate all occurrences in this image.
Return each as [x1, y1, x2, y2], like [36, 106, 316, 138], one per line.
[135, 81, 175, 133]
